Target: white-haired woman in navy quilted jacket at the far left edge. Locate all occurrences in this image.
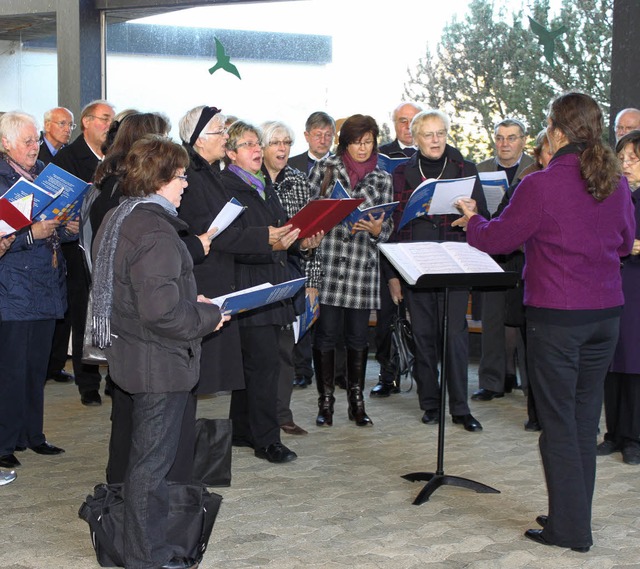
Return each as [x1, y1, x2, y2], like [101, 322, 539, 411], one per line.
[0, 111, 73, 468]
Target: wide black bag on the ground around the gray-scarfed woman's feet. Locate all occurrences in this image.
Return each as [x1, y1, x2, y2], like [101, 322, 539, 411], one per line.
[78, 482, 222, 567]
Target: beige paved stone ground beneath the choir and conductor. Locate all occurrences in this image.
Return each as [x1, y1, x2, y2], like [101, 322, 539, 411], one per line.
[0, 360, 640, 569]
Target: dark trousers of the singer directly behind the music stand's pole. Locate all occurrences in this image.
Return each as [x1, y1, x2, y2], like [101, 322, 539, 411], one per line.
[403, 287, 470, 415]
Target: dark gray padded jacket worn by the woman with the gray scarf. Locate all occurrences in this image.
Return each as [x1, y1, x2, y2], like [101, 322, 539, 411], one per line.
[94, 203, 221, 394]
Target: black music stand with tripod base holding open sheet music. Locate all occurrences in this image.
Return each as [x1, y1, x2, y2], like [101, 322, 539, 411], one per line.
[402, 272, 519, 506]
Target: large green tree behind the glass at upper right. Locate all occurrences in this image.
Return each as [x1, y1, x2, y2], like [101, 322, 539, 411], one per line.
[405, 0, 613, 160]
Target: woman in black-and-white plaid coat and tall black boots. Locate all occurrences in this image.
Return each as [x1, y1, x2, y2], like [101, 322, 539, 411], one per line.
[309, 115, 393, 427]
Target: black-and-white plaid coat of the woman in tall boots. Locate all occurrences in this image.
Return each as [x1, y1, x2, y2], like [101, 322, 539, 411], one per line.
[309, 156, 393, 309]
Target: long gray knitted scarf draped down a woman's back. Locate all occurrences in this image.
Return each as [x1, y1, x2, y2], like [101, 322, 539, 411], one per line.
[91, 194, 178, 348]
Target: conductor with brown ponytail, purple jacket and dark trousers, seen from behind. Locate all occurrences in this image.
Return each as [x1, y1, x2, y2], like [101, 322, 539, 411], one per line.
[454, 93, 635, 552]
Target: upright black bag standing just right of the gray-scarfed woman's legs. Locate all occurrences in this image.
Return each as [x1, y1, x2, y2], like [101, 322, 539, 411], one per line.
[193, 419, 232, 486]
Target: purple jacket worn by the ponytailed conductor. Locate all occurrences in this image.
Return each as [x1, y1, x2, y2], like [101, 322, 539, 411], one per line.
[467, 154, 636, 310]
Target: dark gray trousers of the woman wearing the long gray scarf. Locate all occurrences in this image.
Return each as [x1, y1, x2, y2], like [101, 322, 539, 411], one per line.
[124, 391, 188, 569]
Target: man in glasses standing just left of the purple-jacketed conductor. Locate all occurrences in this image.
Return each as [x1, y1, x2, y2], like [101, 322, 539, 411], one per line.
[471, 118, 534, 401]
